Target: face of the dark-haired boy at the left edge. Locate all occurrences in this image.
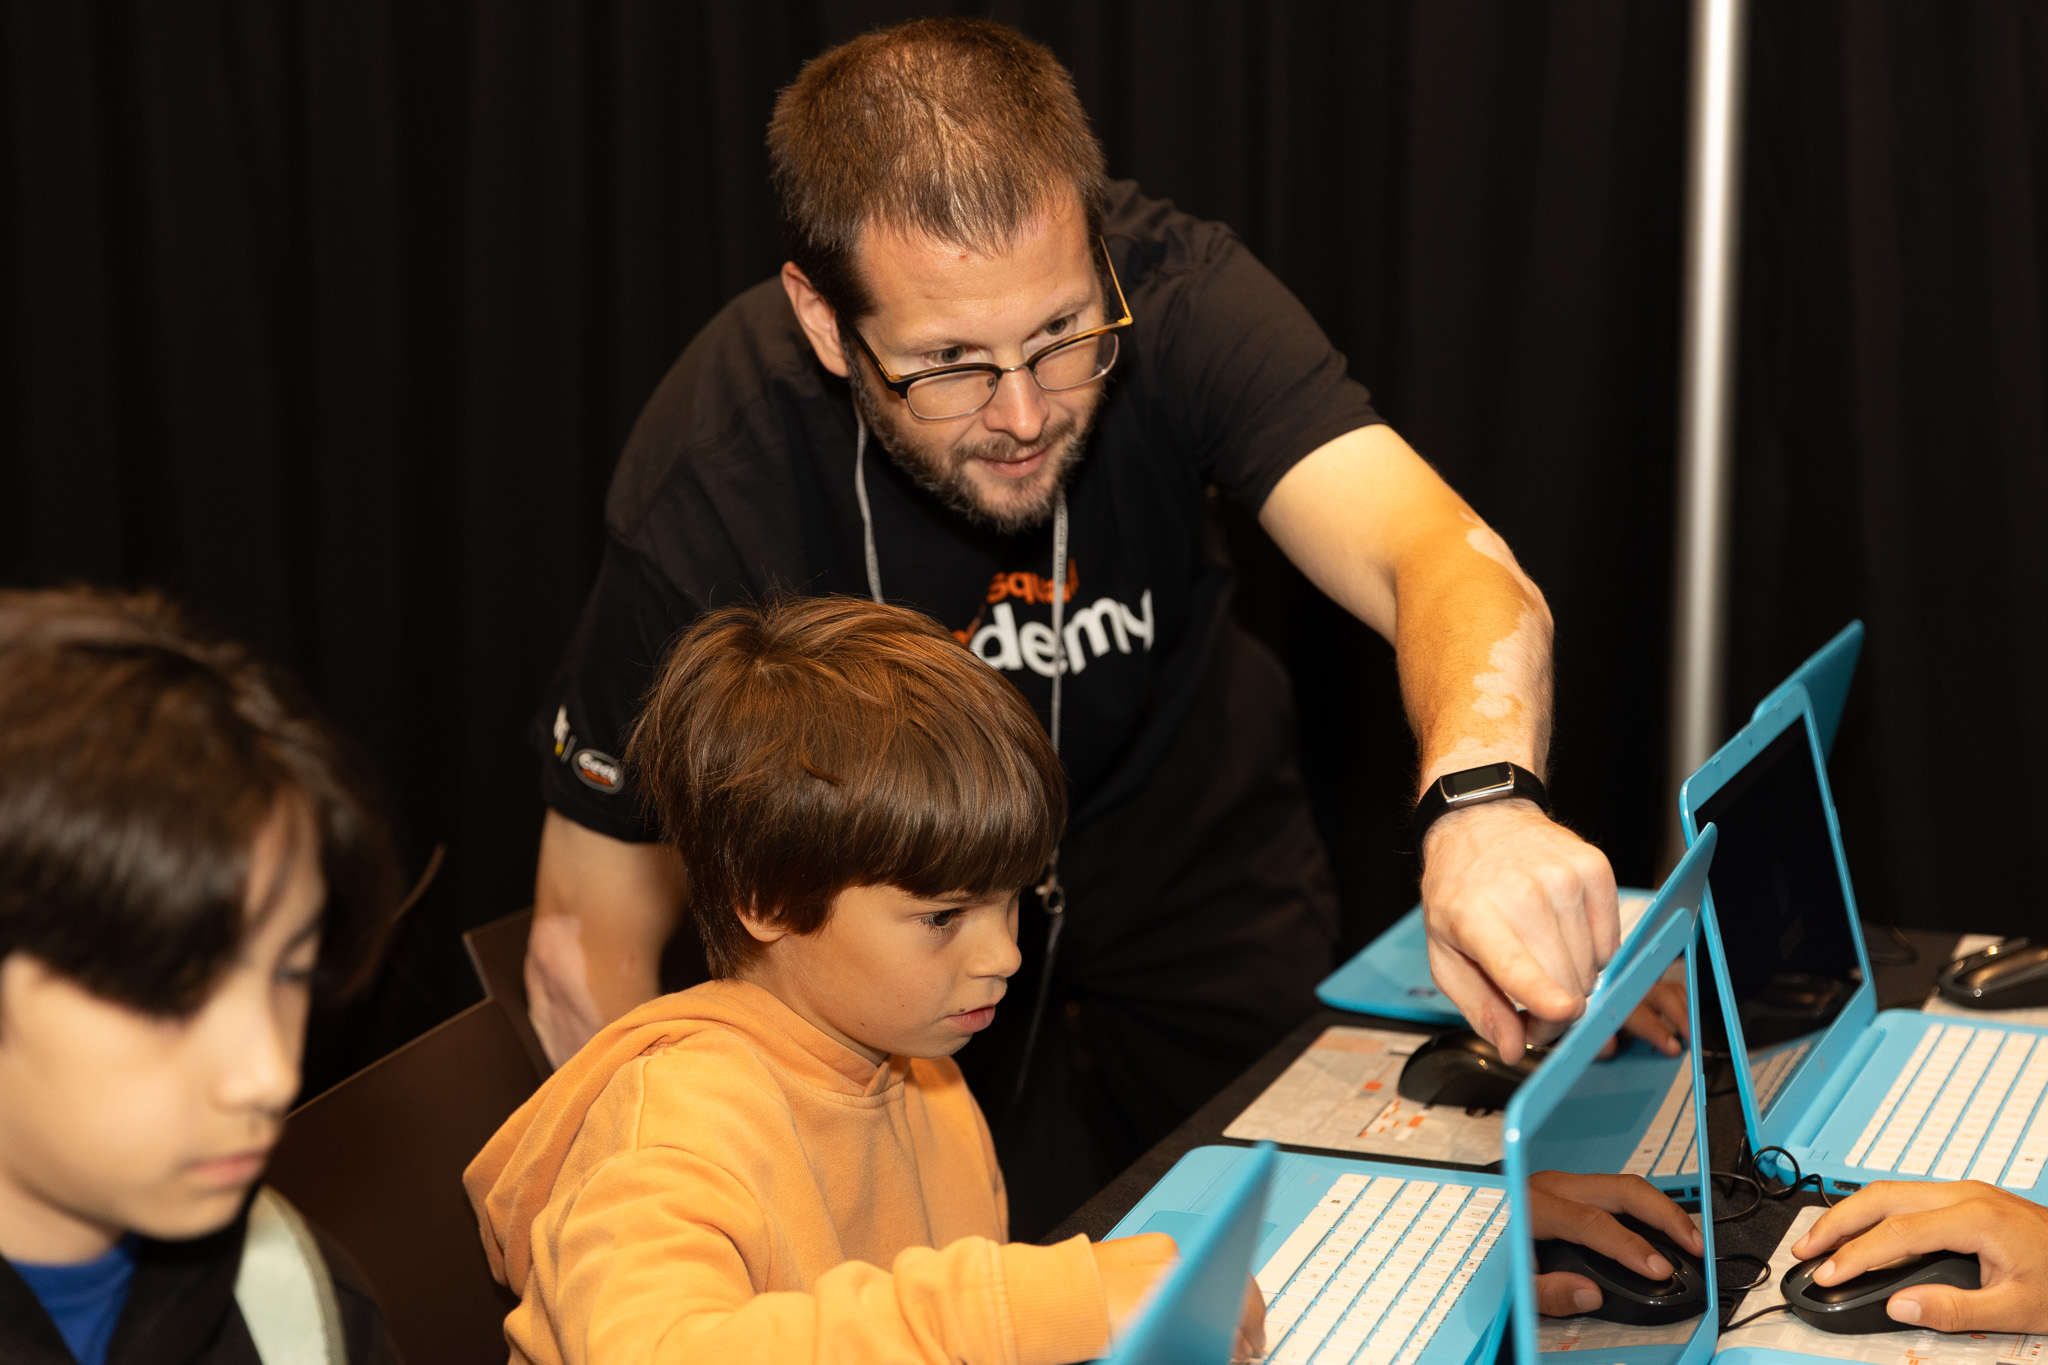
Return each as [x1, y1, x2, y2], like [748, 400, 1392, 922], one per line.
[0, 802, 326, 1263]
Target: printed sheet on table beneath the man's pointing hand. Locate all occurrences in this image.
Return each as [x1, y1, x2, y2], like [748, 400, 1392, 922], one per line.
[1223, 1023, 1507, 1162]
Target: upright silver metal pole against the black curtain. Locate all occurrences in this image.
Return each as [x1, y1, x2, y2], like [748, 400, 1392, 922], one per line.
[1663, 0, 1749, 868]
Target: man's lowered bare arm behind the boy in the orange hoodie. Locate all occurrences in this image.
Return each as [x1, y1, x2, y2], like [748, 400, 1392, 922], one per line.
[526, 810, 682, 1066]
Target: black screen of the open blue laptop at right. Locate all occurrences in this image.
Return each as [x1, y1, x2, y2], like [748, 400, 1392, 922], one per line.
[1694, 716, 1864, 1058]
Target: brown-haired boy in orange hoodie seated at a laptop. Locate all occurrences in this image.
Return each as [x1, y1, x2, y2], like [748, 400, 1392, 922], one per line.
[465, 598, 1220, 1365]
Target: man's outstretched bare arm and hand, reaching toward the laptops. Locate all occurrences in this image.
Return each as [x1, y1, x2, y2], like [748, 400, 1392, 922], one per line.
[1260, 426, 1620, 1056]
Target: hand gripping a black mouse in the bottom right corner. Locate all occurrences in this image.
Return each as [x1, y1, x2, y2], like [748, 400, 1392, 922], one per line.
[1792, 1181, 2048, 1332]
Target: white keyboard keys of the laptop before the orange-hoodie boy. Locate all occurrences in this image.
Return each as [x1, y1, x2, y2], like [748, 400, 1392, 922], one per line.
[1257, 1175, 1507, 1365]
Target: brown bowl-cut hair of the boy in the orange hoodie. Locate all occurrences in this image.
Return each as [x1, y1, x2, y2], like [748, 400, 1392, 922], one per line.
[627, 598, 1067, 976]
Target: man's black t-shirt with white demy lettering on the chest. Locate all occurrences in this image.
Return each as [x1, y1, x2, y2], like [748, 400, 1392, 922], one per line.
[535, 182, 1378, 841]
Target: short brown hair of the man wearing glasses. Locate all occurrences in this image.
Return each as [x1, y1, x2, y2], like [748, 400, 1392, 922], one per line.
[768, 18, 1108, 325]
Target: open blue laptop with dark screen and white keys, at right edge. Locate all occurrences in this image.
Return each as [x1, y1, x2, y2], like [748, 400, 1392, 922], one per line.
[1679, 684, 2048, 1203]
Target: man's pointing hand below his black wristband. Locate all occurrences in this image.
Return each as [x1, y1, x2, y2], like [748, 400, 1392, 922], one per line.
[1421, 800, 1622, 1058]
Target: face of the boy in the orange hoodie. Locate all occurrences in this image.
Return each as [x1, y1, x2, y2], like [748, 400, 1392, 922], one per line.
[739, 886, 1022, 1064]
